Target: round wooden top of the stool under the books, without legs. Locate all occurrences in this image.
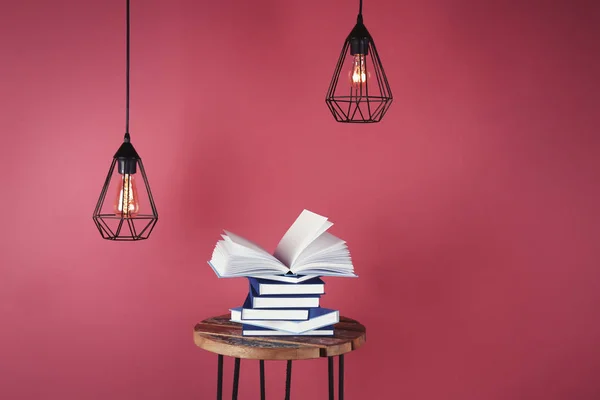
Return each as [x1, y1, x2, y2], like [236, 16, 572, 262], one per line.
[194, 314, 366, 360]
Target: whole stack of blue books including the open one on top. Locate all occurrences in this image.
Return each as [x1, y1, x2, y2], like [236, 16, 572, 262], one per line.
[209, 210, 356, 336]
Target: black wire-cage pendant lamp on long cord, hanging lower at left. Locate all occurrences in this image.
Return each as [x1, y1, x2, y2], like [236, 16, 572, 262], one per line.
[93, 0, 158, 241]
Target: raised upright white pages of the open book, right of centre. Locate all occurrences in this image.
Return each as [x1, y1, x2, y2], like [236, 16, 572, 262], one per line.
[275, 210, 333, 267]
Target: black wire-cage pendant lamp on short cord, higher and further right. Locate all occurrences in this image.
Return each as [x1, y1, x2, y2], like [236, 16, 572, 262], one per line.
[325, 0, 392, 123]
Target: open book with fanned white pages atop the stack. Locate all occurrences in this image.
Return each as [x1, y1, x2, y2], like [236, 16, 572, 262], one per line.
[208, 210, 356, 283]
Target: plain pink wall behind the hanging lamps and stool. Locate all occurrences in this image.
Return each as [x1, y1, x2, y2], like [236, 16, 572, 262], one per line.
[0, 0, 600, 400]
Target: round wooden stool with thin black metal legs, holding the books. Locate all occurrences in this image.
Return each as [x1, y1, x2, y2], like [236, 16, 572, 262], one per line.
[194, 314, 366, 400]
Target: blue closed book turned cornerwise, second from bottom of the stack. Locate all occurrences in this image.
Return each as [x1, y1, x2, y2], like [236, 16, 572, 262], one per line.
[231, 308, 340, 334]
